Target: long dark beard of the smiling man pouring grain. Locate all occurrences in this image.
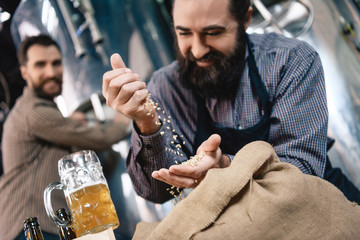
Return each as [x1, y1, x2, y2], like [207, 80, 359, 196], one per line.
[177, 25, 246, 98]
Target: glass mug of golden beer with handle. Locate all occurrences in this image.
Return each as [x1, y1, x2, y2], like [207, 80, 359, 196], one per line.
[44, 150, 120, 237]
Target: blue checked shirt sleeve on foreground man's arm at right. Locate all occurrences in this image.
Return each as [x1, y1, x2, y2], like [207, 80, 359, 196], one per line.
[269, 39, 328, 177]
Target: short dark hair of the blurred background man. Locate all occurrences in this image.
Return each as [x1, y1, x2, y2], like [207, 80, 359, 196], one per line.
[18, 34, 61, 65]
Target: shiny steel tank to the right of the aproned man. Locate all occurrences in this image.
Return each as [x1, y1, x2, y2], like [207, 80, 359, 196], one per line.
[249, 0, 360, 188]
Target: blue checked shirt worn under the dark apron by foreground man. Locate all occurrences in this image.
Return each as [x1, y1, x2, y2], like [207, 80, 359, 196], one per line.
[126, 33, 328, 202]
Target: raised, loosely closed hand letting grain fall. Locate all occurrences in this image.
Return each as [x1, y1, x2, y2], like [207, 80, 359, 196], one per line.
[102, 53, 160, 135]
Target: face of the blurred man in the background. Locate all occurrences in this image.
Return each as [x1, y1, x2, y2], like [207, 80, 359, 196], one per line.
[21, 44, 63, 99]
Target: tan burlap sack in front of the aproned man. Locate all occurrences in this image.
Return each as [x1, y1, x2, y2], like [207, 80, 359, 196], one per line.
[133, 141, 360, 240]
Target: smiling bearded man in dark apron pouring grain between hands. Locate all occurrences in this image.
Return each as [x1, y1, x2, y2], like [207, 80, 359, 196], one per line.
[103, 0, 360, 202]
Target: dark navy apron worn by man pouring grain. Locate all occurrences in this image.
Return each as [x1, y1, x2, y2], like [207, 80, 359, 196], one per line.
[194, 33, 360, 204]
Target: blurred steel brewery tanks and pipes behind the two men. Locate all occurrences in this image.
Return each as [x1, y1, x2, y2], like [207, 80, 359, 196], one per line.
[0, 0, 360, 239]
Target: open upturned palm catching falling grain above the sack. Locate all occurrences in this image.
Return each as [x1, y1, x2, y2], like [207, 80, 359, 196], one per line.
[152, 134, 230, 188]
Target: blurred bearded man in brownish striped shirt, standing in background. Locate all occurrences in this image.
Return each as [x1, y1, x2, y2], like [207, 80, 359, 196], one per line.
[0, 35, 126, 240]
